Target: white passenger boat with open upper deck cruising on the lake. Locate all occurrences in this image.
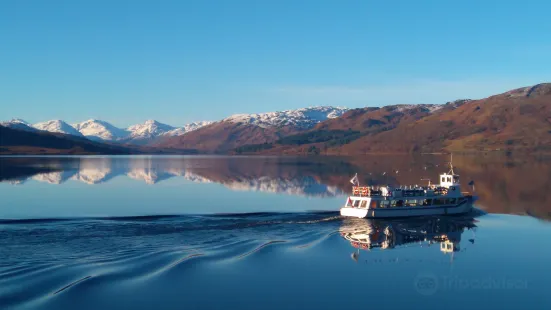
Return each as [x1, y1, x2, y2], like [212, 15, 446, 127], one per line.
[340, 162, 474, 218]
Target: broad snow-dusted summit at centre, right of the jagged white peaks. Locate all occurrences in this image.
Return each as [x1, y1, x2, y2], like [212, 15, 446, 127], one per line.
[223, 106, 348, 129]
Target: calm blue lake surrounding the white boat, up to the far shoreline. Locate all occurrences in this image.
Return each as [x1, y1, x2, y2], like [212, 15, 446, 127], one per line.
[0, 155, 551, 309]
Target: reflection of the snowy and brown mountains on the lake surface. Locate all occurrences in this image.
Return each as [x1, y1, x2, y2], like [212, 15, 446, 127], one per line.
[0, 155, 551, 219]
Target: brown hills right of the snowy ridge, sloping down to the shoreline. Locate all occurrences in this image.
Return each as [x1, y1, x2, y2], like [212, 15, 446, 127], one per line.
[240, 84, 551, 155]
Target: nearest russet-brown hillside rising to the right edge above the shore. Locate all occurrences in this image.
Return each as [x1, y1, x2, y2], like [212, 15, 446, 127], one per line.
[339, 84, 551, 153]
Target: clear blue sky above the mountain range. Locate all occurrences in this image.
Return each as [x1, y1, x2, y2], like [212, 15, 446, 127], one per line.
[0, 0, 551, 126]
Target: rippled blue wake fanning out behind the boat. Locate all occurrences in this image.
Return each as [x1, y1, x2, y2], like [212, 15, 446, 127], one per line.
[0, 212, 341, 308]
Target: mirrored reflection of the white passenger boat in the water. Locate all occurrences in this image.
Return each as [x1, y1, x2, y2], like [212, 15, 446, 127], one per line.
[340, 216, 477, 260]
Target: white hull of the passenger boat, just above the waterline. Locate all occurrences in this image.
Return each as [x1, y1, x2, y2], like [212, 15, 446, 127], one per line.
[341, 202, 473, 218]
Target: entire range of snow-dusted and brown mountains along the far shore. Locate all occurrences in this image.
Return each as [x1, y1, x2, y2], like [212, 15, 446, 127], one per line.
[0, 83, 551, 155]
